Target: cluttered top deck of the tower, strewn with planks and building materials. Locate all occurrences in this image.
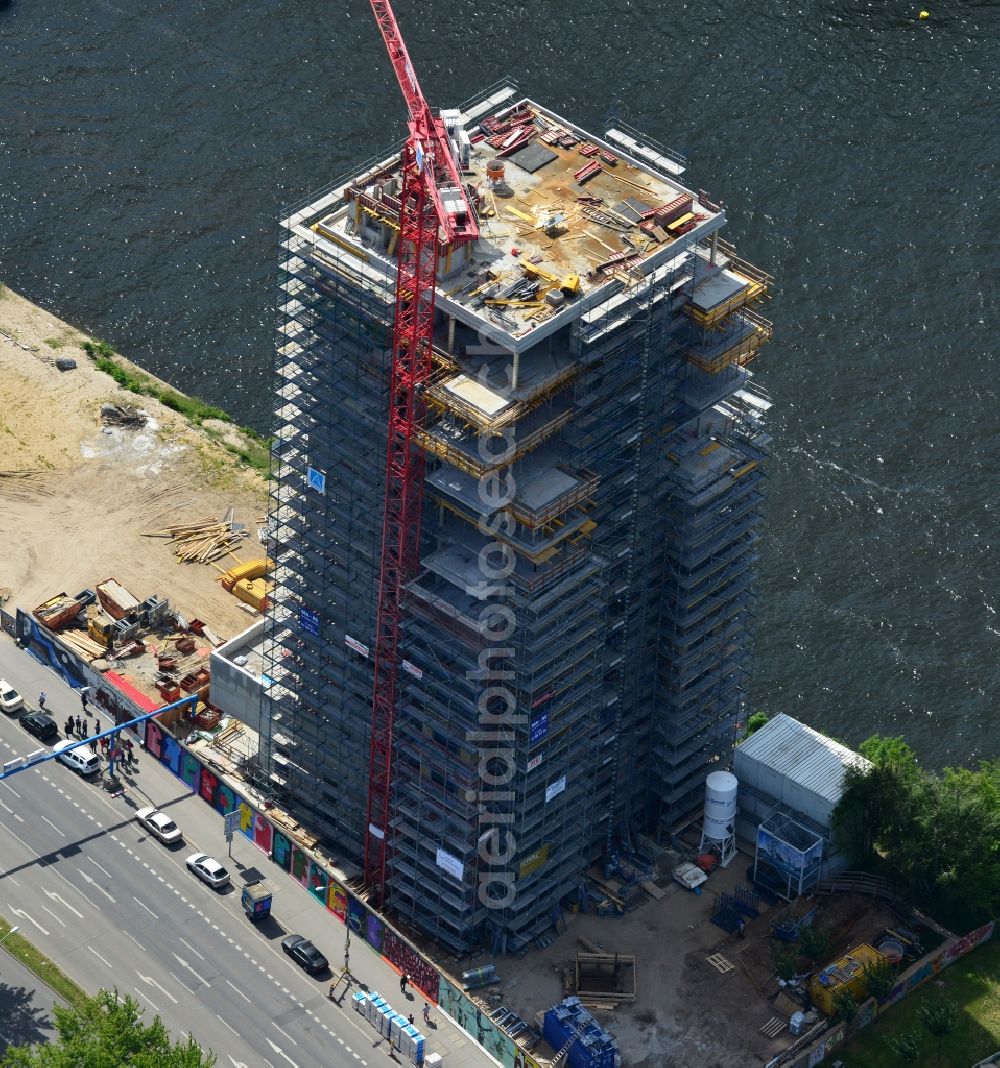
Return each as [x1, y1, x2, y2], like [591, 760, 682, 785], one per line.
[284, 94, 721, 351]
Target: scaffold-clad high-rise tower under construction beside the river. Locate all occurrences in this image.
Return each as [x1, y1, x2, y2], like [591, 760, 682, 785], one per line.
[262, 83, 771, 952]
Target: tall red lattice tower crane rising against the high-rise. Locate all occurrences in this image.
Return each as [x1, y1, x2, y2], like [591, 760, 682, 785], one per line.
[364, 0, 479, 907]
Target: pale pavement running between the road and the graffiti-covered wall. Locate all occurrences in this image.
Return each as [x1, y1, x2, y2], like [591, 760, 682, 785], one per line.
[0, 634, 499, 1068]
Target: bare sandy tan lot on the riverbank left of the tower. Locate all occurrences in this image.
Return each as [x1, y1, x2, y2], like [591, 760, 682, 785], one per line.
[0, 287, 267, 637]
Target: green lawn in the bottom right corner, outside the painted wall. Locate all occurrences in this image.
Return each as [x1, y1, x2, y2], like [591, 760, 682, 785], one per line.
[837, 940, 1000, 1068]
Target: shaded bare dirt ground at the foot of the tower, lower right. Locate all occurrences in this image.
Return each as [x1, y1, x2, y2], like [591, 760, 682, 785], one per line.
[472, 854, 892, 1068]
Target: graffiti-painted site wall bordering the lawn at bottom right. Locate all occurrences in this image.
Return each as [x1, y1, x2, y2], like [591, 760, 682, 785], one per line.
[766, 920, 998, 1068]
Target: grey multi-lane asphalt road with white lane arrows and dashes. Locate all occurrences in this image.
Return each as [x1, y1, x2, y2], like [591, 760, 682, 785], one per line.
[0, 641, 376, 1068]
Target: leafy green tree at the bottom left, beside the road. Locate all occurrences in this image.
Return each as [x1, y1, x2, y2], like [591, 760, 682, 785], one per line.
[0, 990, 216, 1068]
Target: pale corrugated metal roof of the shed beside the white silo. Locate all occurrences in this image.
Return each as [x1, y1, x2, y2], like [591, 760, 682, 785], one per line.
[735, 712, 871, 804]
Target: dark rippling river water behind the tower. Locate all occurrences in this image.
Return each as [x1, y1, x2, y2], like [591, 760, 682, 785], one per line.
[0, 0, 1000, 765]
